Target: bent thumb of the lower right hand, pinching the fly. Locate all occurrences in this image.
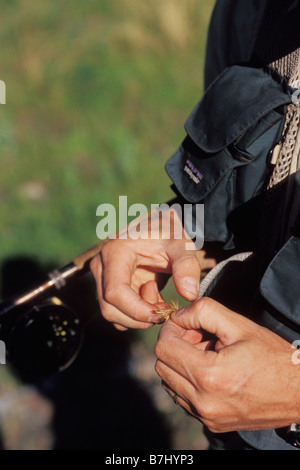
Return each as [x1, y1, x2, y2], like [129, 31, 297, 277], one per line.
[171, 297, 244, 346]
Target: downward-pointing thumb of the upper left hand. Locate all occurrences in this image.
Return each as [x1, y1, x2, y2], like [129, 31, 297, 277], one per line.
[171, 249, 201, 301]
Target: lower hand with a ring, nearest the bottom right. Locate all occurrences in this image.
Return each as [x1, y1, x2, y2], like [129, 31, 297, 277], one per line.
[155, 298, 300, 432]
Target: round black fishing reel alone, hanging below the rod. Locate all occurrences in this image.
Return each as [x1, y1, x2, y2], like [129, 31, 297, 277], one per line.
[1, 297, 83, 377]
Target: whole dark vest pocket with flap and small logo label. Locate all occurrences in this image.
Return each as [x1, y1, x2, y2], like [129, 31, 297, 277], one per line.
[166, 66, 291, 248]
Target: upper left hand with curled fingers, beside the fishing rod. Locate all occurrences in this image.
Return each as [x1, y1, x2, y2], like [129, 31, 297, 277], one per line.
[91, 209, 215, 330]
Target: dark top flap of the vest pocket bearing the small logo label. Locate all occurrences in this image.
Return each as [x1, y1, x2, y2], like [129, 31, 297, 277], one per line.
[185, 65, 291, 153]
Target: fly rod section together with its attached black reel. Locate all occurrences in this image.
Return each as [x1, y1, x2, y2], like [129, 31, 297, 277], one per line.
[0, 240, 108, 377]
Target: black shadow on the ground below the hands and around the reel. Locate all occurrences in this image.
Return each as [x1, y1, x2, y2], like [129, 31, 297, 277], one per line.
[0, 257, 171, 450]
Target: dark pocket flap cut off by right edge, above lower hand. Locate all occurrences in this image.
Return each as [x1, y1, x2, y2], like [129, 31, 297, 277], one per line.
[260, 237, 300, 325]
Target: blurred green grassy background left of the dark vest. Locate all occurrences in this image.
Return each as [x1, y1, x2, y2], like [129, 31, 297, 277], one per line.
[0, 0, 214, 447]
